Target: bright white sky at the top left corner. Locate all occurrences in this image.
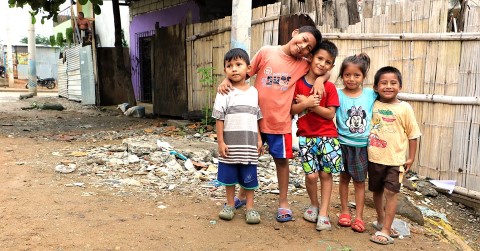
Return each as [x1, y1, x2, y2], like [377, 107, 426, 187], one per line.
[0, 0, 54, 44]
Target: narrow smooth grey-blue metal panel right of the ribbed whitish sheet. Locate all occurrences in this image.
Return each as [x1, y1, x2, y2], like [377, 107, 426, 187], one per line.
[80, 45, 95, 105]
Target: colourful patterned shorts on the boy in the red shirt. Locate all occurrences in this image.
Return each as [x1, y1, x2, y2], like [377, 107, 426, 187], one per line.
[299, 136, 343, 174]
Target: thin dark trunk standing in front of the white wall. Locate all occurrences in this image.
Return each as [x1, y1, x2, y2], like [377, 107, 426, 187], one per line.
[112, 0, 137, 107]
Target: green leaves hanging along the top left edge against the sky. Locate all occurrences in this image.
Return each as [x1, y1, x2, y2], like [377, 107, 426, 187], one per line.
[8, 0, 103, 24]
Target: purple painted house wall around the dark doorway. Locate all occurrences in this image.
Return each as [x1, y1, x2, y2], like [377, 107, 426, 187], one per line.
[130, 2, 200, 100]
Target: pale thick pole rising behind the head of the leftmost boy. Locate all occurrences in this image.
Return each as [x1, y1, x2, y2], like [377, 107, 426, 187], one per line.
[230, 0, 252, 55]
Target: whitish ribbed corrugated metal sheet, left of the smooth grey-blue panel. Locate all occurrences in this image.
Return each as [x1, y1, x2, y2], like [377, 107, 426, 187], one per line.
[65, 45, 82, 101]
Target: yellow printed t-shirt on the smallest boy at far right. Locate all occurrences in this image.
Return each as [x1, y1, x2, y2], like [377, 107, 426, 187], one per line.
[368, 100, 422, 166]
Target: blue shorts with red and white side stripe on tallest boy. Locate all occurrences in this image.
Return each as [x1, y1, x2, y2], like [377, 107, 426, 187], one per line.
[262, 133, 293, 159]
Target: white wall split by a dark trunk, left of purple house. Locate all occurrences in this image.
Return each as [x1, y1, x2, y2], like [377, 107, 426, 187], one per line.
[95, 1, 130, 47]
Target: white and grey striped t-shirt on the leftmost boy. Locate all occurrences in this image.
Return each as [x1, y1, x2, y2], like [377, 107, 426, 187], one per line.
[212, 86, 262, 165]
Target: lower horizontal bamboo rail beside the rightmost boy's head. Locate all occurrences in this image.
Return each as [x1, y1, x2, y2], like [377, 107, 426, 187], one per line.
[398, 93, 480, 105]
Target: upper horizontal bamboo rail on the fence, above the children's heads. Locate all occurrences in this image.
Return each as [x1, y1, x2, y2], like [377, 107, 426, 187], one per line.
[322, 32, 480, 41]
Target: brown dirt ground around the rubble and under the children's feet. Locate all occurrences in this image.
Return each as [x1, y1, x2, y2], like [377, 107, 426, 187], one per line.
[0, 94, 478, 250]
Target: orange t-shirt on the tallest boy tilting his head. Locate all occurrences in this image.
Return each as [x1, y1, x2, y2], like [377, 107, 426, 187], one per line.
[250, 46, 310, 134]
